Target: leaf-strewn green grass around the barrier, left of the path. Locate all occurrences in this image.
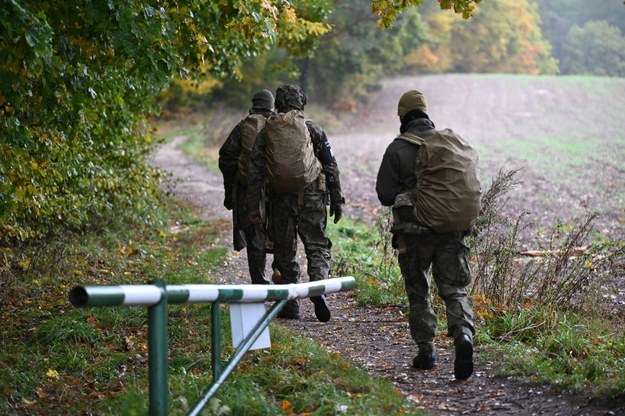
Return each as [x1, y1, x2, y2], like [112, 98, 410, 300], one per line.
[0, 199, 421, 415]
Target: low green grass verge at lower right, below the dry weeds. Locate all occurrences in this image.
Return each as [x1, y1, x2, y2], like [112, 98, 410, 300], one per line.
[481, 309, 625, 400]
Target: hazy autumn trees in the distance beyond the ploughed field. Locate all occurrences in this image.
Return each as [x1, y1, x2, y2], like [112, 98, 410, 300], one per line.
[207, 0, 625, 110]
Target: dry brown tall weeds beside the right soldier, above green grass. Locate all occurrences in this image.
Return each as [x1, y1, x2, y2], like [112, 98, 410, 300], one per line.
[469, 171, 625, 311]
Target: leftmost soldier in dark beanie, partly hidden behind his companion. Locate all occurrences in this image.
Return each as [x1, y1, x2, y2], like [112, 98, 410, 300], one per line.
[219, 90, 275, 284]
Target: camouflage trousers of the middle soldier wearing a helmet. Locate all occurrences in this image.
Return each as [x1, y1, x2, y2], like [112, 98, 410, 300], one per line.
[268, 181, 332, 283]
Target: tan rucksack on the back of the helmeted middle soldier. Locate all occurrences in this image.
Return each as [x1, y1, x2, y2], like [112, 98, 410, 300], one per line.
[265, 110, 321, 192]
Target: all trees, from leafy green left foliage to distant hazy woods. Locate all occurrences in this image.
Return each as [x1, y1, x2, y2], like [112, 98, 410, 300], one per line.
[0, 0, 625, 244]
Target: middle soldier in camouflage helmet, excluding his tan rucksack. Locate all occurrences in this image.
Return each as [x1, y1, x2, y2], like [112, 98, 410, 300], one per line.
[248, 85, 345, 322]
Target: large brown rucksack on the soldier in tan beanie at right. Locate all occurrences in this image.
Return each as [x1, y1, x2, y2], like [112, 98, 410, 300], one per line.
[399, 129, 481, 233]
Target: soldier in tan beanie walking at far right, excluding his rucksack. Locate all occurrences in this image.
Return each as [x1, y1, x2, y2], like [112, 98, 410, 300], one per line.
[376, 90, 475, 380]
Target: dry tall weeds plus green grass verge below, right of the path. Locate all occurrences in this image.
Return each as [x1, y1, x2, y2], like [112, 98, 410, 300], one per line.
[470, 171, 625, 399]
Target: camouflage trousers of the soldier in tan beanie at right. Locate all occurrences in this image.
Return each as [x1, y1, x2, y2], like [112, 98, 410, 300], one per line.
[395, 228, 475, 344]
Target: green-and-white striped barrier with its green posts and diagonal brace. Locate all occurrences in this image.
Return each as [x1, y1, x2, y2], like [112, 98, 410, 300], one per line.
[69, 277, 356, 416]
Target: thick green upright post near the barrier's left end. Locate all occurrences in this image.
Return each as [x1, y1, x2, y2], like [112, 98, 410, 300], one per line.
[148, 280, 169, 416]
